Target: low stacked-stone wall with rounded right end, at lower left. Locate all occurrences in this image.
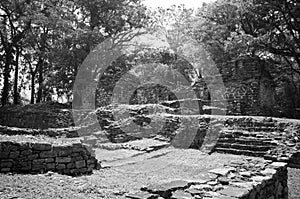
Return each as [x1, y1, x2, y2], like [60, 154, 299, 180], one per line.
[0, 141, 98, 175]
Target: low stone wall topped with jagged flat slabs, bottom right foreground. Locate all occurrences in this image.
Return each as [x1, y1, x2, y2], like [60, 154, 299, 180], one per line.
[126, 158, 288, 199]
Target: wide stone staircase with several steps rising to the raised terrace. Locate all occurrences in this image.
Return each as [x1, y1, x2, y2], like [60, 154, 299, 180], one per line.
[214, 121, 284, 159]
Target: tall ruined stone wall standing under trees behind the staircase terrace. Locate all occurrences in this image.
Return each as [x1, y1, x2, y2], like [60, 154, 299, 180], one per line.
[219, 57, 275, 116]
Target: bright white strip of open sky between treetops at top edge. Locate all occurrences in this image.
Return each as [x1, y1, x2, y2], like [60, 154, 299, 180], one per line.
[143, 0, 215, 8]
